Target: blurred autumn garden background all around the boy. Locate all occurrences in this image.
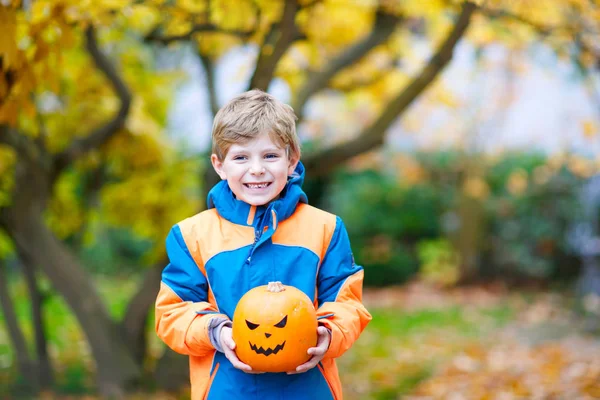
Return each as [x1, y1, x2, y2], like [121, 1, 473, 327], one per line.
[0, 0, 600, 400]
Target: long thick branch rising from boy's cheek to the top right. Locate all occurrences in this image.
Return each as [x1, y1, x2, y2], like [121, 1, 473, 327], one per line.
[304, 2, 477, 176]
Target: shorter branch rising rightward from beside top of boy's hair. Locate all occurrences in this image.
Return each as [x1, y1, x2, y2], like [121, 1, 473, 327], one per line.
[291, 11, 401, 119]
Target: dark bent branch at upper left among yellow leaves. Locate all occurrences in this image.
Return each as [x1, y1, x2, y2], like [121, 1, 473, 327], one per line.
[52, 26, 131, 180]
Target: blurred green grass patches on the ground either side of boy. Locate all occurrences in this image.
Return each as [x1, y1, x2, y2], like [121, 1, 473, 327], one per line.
[0, 278, 514, 400]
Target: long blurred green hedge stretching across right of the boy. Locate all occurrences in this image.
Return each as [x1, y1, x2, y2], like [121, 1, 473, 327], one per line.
[324, 152, 585, 286]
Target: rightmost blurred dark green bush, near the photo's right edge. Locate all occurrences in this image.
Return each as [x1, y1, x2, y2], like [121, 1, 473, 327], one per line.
[485, 162, 584, 278]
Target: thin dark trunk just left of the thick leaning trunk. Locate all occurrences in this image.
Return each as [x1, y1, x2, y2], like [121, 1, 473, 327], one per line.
[22, 260, 54, 389]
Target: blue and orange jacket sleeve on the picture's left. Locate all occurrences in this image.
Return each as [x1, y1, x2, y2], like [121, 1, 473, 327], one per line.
[155, 225, 227, 356]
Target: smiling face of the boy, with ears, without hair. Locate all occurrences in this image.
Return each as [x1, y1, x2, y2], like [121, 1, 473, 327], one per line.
[210, 133, 298, 206]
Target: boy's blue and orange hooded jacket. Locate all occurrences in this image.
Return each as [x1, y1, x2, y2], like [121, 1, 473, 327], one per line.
[155, 163, 371, 400]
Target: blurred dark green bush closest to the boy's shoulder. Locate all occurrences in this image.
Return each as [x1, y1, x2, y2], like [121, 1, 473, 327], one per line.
[327, 170, 442, 286]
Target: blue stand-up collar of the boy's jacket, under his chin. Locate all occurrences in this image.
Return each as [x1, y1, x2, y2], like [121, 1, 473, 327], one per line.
[206, 162, 308, 229]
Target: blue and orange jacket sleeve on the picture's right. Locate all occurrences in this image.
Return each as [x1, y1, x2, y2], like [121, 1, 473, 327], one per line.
[317, 217, 371, 358]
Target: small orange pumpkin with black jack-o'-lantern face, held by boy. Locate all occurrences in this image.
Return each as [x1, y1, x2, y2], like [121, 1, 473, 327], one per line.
[232, 282, 317, 372]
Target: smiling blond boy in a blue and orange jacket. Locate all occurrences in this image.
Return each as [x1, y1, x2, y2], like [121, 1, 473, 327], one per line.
[155, 90, 371, 400]
